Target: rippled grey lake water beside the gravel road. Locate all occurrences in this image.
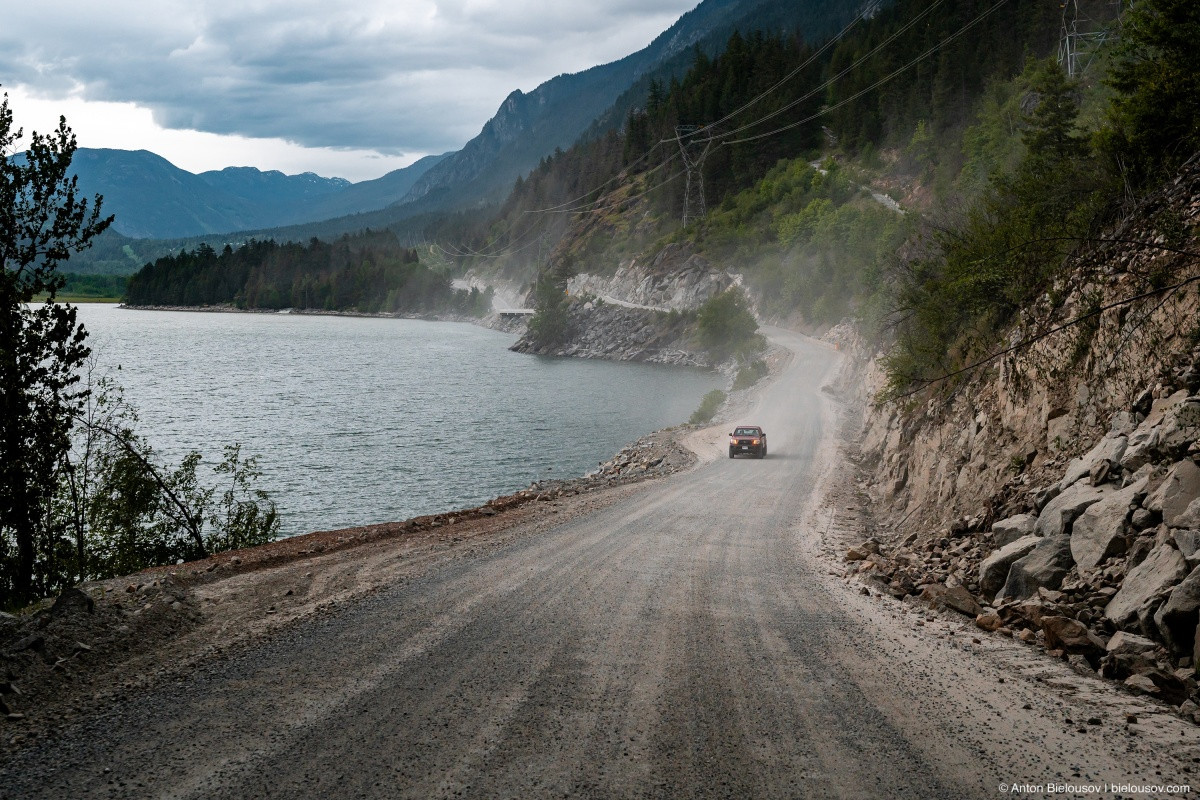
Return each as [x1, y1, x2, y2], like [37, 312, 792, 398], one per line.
[79, 305, 719, 535]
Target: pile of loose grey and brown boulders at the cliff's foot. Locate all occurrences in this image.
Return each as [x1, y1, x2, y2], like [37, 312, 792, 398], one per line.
[845, 348, 1200, 722]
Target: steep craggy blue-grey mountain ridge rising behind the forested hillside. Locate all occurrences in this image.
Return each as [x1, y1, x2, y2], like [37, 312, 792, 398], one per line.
[404, 0, 862, 212]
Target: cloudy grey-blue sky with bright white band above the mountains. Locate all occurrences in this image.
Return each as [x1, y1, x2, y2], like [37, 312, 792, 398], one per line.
[0, 0, 698, 181]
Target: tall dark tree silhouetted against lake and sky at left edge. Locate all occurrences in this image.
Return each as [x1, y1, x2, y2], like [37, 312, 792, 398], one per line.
[0, 95, 113, 602]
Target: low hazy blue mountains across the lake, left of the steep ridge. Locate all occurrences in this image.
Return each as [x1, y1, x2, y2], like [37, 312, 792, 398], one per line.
[72, 148, 445, 239]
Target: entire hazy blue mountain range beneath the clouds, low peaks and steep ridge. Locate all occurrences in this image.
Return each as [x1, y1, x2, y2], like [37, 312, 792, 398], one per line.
[58, 0, 864, 272]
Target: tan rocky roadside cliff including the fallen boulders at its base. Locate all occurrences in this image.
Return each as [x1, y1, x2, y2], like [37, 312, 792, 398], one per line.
[847, 159, 1200, 721]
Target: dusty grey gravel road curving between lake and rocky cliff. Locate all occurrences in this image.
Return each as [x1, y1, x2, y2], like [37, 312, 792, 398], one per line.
[0, 330, 1200, 800]
